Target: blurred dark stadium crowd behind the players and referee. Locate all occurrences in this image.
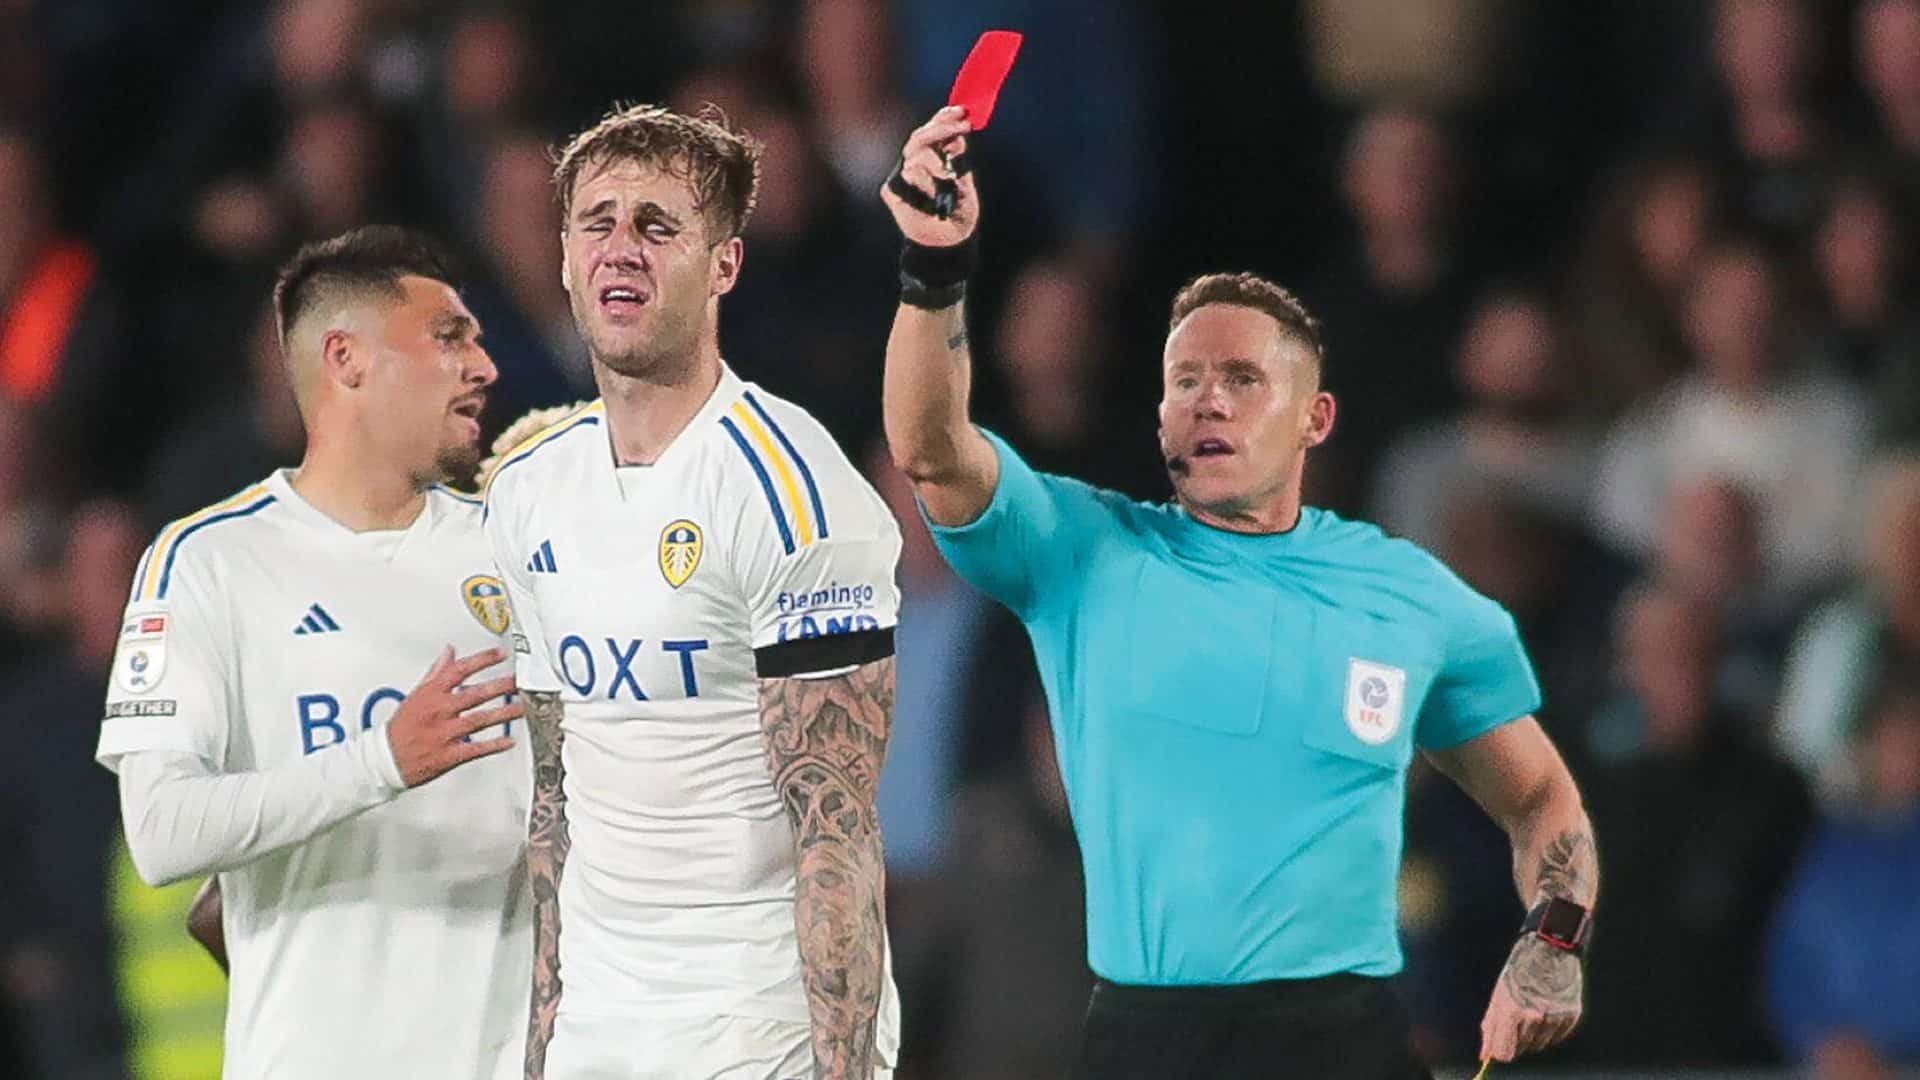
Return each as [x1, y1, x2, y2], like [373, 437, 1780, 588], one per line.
[0, 0, 1920, 1080]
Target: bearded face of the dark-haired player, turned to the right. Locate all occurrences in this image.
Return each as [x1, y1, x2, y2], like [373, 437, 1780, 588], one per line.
[361, 275, 499, 484]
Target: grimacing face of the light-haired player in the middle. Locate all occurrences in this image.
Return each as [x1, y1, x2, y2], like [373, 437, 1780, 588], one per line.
[561, 160, 741, 377]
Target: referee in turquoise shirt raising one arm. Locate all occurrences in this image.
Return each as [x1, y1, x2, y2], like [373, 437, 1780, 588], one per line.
[881, 108, 1599, 1080]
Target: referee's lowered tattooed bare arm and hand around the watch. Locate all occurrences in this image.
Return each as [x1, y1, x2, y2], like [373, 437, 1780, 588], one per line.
[1428, 717, 1599, 1061]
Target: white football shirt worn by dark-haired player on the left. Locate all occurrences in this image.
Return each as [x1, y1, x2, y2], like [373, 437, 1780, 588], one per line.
[98, 473, 532, 1080]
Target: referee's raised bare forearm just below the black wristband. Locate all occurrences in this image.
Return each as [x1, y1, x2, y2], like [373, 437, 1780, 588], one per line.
[881, 302, 979, 482]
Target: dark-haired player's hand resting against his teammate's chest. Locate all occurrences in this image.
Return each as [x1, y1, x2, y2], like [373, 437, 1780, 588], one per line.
[386, 646, 526, 788]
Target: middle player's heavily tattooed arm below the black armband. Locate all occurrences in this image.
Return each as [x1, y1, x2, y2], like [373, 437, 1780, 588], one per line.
[760, 657, 895, 1080]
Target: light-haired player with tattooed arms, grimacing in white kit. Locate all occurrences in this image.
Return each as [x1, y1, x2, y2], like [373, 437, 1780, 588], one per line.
[486, 108, 900, 1080]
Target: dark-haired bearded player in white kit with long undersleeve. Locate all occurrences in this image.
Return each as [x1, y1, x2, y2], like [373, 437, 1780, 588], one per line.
[98, 229, 532, 1080]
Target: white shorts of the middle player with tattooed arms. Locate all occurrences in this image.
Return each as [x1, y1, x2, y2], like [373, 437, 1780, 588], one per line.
[545, 1013, 893, 1080]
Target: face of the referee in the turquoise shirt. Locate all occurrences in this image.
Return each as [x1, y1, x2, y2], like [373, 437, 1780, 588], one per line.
[1160, 304, 1332, 517]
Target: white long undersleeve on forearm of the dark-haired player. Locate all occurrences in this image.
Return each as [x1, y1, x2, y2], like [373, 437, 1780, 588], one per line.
[119, 730, 405, 886]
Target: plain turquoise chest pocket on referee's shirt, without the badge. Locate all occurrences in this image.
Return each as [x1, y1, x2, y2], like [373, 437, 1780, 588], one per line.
[1119, 559, 1277, 734]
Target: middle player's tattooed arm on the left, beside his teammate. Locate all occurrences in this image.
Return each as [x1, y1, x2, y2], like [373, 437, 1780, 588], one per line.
[522, 690, 570, 1080]
